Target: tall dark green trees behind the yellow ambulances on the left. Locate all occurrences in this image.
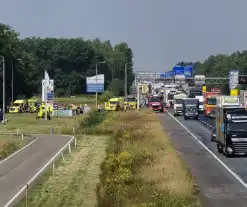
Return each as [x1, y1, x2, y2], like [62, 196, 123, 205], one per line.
[0, 23, 134, 100]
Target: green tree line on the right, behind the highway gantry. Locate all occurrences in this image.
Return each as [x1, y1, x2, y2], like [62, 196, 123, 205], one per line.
[177, 50, 247, 94]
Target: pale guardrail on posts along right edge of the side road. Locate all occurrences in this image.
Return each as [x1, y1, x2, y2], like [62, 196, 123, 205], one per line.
[4, 135, 76, 207]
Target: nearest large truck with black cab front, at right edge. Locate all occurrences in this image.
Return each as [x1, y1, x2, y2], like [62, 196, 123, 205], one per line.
[215, 96, 247, 157]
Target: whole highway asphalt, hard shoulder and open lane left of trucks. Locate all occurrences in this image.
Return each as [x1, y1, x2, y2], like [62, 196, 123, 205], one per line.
[157, 113, 247, 207]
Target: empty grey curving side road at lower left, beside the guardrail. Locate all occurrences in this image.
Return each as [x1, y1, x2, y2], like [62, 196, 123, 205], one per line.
[0, 135, 71, 207]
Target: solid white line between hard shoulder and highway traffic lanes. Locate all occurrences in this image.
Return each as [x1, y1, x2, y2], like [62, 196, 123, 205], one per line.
[168, 112, 247, 189]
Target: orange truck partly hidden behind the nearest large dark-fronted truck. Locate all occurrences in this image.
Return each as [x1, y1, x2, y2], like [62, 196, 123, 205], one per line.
[203, 91, 221, 117]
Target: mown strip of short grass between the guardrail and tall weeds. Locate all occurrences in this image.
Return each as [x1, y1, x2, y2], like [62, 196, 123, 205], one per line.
[19, 136, 107, 207]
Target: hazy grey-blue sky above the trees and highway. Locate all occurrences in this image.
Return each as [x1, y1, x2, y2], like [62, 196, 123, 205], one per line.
[0, 0, 247, 71]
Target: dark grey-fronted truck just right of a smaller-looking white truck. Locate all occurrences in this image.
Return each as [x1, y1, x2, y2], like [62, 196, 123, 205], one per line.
[183, 98, 199, 120]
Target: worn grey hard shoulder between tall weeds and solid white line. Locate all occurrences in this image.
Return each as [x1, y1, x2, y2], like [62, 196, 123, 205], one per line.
[157, 114, 247, 207]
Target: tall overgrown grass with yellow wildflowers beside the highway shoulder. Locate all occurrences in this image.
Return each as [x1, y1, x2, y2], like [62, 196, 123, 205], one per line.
[97, 110, 202, 207]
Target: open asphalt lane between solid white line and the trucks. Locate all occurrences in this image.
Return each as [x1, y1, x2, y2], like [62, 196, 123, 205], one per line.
[178, 117, 247, 183]
